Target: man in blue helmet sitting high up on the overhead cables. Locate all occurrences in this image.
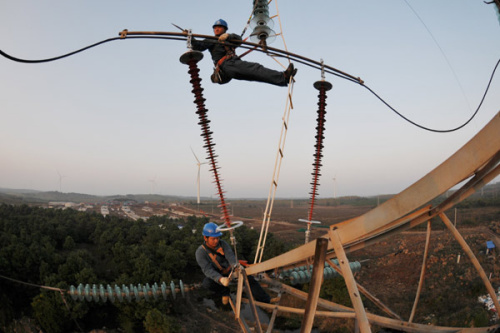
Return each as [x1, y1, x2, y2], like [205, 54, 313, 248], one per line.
[191, 19, 297, 87]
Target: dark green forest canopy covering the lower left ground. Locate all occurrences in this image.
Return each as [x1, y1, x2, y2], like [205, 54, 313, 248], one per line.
[0, 204, 286, 332]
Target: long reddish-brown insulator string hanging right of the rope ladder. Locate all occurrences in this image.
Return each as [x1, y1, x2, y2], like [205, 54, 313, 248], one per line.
[308, 81, 332, 221]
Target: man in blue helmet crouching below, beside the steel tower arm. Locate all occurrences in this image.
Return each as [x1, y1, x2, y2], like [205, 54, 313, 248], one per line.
[196, 222, 270, 305]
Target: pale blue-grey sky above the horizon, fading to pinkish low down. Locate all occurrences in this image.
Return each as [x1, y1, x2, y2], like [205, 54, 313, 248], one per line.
[0, 0, 500, 198]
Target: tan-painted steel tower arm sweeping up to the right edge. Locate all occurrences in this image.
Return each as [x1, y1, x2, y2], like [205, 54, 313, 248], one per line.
[246, 112, 500, 332]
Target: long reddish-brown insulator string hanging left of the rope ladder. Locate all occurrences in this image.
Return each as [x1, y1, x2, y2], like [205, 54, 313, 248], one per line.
[181, 51, 231, 227]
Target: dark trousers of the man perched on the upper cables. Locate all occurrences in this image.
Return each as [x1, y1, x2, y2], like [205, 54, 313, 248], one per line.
[220, 57, 288, 87]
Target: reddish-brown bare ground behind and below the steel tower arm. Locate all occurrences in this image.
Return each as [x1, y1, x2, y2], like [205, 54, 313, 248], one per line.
[176, 204, 500, 327]
